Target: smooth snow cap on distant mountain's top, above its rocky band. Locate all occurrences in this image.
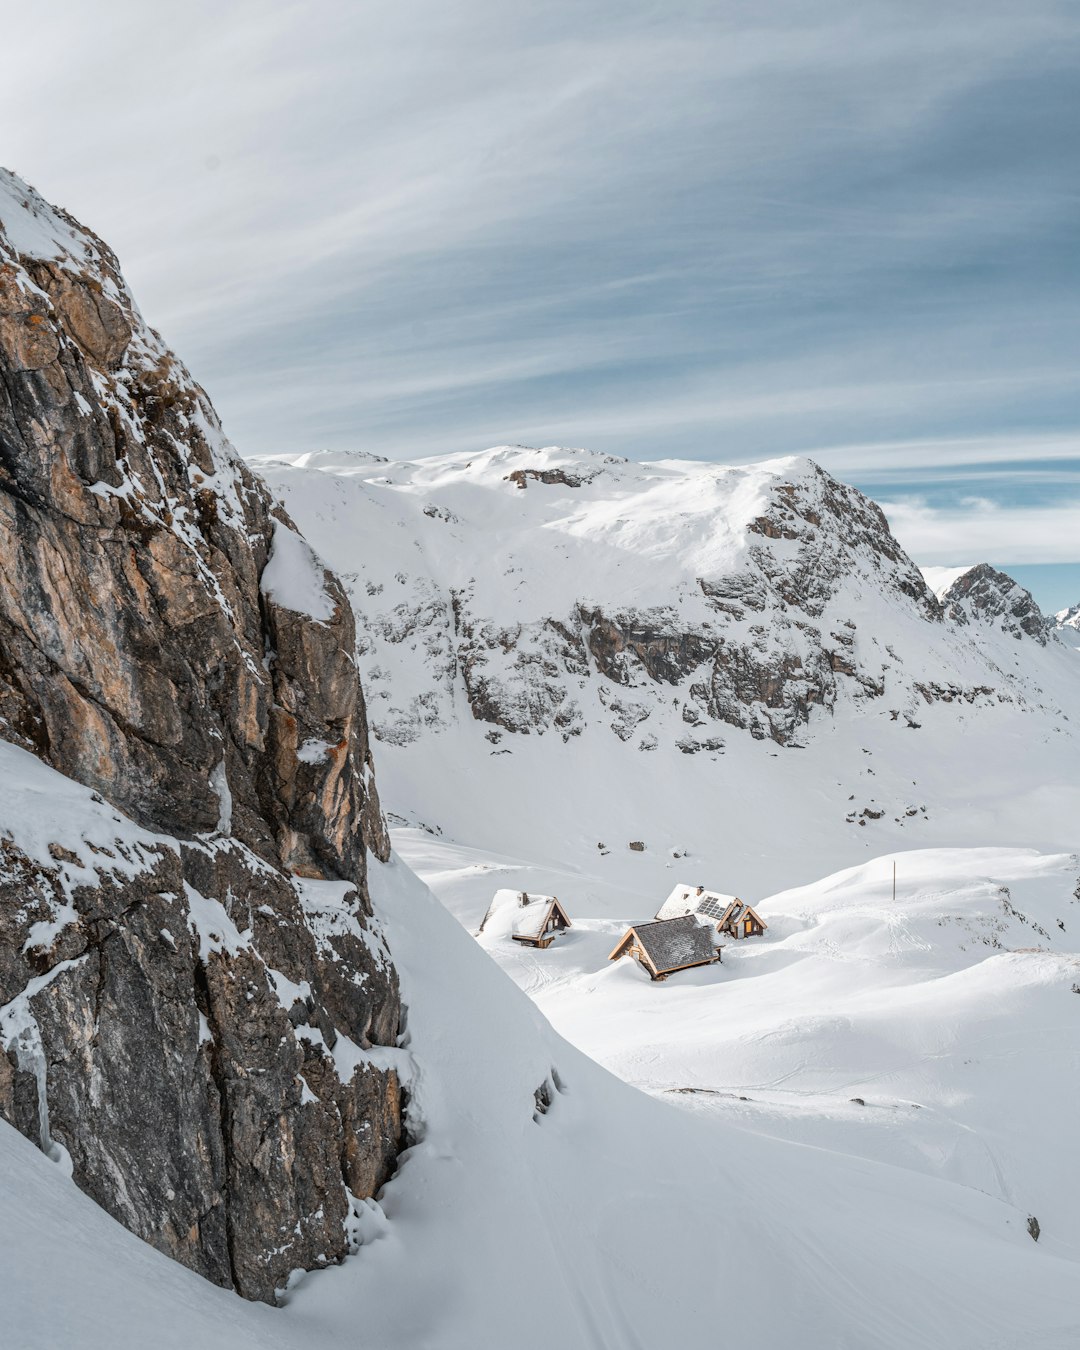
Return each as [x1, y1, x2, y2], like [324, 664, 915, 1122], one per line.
[251, 446, 810, 621]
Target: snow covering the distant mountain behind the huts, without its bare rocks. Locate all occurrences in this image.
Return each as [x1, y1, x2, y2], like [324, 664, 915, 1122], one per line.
[255, 447, 1080, 891]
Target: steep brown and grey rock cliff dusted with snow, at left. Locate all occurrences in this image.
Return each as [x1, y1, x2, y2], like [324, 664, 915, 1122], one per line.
[0, 174, 401, 1299]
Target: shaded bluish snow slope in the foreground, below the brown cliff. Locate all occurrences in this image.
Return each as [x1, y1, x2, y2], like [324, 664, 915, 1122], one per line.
[0, 752, 1080, 1350]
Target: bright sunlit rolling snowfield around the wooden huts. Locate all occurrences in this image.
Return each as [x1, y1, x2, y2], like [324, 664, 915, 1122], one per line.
[398, 832, 1080, 1274]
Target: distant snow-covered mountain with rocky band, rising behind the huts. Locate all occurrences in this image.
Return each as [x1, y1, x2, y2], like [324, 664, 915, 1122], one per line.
[257, 447, 1080, 903]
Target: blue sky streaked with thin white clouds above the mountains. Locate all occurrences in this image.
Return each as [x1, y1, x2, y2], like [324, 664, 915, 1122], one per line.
[0, 0, 1080, 609]
